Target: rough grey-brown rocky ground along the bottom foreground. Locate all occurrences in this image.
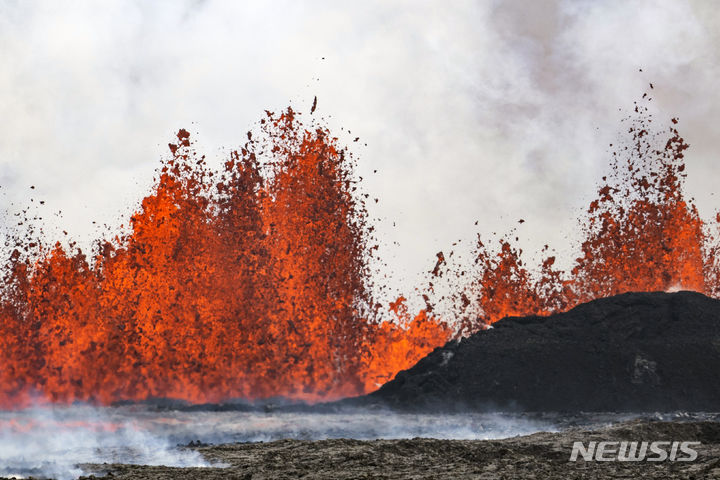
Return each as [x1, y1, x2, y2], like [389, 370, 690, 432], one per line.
[69, 419, 720, 480]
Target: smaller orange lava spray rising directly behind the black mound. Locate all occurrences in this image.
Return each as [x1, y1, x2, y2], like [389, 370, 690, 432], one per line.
[444, 100, 720, 335]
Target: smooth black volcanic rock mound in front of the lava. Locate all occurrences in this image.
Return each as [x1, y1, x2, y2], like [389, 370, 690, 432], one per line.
[359, 292, 720, 411]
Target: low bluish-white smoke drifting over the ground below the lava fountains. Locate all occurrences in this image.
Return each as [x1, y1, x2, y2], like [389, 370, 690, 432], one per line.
[0, 405, 555, 480]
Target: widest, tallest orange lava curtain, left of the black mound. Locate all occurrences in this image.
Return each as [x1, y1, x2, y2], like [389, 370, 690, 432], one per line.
[0, 109, 450, 407]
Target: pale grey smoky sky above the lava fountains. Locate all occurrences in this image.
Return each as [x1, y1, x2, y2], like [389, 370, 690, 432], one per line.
[0, 0, 720, 300]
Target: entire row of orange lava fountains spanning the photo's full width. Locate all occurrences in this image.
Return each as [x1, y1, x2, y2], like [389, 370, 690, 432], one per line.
[0, 96, 720, 408]
